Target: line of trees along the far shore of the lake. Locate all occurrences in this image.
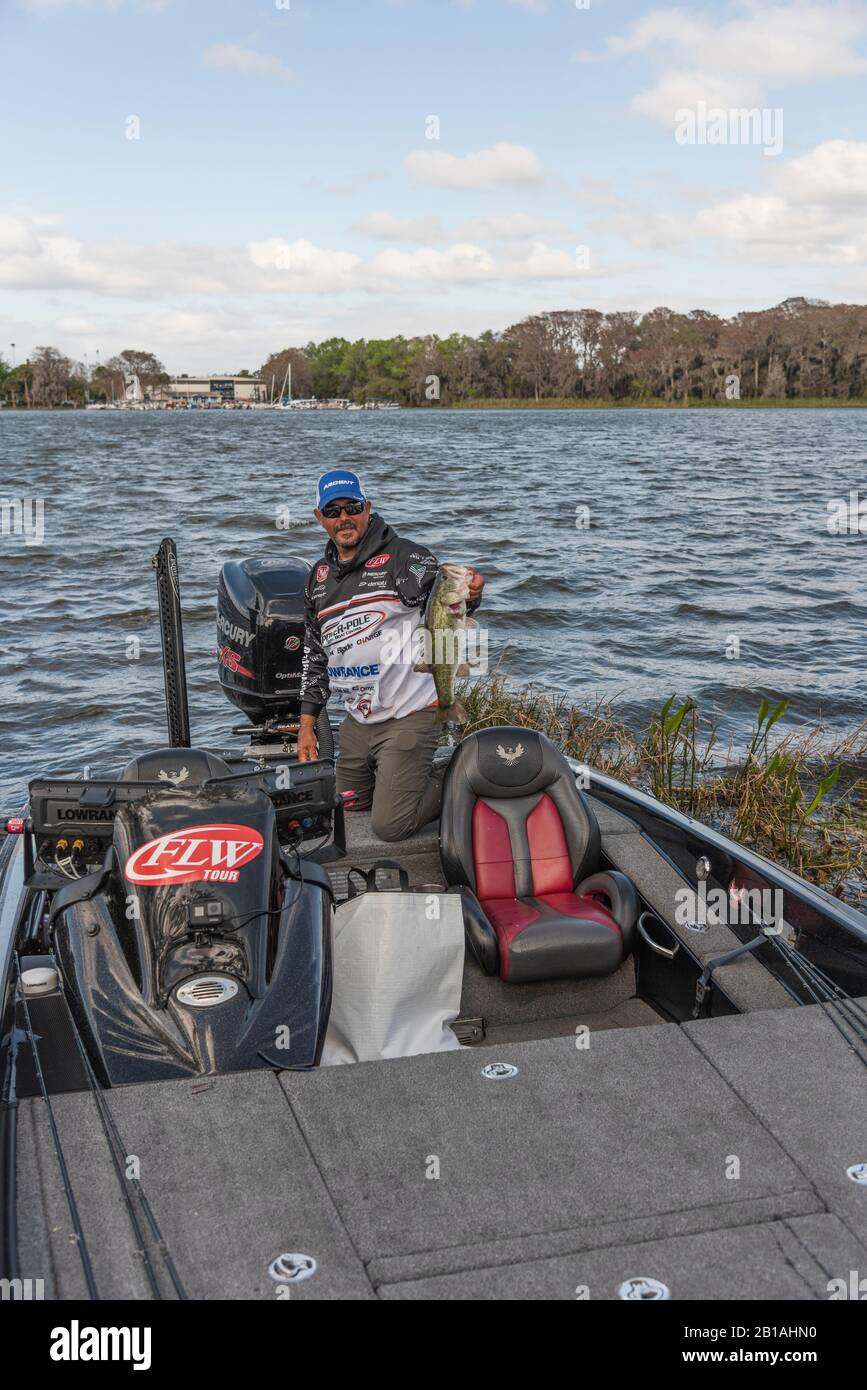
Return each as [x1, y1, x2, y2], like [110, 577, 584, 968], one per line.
[0, 297, 867, 406]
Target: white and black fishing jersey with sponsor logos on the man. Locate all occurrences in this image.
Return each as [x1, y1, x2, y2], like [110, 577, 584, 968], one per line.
[302, 513, 477, 724]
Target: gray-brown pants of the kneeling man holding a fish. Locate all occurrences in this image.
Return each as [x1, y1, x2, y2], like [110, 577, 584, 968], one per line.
[338, 708, 442, 840]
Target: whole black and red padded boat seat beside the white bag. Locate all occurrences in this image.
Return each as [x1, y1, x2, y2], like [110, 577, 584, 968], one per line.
[439, 727, 639, 984]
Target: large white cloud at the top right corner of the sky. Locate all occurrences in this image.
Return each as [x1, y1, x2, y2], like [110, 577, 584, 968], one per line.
[575, 0, 867, 125]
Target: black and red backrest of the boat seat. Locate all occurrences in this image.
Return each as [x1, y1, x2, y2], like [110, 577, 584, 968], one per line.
[439, 726, 600, 901]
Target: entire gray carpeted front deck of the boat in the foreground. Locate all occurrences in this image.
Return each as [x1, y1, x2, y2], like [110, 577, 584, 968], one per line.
[18, 1008, 867, 1300]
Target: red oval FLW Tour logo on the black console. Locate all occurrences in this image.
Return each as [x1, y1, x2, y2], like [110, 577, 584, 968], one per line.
[124, 826, 264, 888]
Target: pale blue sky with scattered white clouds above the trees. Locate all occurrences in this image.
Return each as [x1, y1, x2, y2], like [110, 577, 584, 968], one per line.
[0, 0, 867, 374]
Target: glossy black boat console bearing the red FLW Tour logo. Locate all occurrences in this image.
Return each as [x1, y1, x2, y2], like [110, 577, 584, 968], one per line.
[51, 748, 332, 1086]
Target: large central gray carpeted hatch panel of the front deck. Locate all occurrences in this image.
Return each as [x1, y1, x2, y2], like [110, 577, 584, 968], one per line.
[282, 1026, 810, 1261]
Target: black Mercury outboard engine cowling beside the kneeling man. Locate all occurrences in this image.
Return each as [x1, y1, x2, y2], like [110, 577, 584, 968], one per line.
[217, 556, 310, 724]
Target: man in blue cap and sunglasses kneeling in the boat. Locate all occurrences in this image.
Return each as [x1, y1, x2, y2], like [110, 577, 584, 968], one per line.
[297, 468, 485, 841]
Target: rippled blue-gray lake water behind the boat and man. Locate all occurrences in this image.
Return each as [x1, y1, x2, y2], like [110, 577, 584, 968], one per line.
[0, 410, 867, 810]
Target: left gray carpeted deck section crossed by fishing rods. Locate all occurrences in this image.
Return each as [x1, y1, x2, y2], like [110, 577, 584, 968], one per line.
[18, 1072, 372, 1300]
